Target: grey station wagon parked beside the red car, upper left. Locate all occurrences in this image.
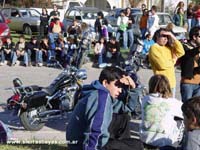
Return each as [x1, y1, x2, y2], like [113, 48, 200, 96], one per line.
[1, 8, 40, 35]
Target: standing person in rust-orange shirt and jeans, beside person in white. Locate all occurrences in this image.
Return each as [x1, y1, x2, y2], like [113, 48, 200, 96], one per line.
[140, 9, 148, 39]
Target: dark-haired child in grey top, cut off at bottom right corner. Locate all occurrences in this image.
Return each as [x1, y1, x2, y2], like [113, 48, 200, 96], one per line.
[181, 96, 200, 150]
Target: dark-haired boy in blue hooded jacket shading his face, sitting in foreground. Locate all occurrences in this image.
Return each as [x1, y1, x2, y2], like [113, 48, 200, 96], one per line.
[66, 67, 142, 150]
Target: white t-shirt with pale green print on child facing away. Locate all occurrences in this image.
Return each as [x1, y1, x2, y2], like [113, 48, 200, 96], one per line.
[140, 93, 184, 147]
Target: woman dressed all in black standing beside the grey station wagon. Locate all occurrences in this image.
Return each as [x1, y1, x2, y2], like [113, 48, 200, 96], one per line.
[40, 7, 49, 38]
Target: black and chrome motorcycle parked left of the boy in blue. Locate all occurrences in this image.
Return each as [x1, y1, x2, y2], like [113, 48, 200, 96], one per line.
[7, 67, 87, 131]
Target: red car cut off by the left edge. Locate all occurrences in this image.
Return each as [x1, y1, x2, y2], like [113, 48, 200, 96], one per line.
[0, 12, 10, 42]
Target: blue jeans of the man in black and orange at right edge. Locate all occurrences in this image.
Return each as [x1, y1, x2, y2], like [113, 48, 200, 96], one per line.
[180, 83, 200, 102]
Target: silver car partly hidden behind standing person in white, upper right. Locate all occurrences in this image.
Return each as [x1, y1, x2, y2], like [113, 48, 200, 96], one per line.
[133, 12, 187, 40]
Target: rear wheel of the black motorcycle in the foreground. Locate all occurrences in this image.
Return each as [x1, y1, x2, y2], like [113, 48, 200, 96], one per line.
[19, 106, 46, 131]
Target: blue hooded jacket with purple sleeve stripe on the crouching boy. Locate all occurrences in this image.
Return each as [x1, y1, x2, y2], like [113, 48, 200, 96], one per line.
[66, 81, 137, 150]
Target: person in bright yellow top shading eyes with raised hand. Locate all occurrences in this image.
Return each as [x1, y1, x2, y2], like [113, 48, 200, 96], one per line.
[149, 28, 185, 97]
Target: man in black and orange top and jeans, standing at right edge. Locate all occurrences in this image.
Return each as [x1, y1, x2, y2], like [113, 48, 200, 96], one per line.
[180, 27, 200, 102]
